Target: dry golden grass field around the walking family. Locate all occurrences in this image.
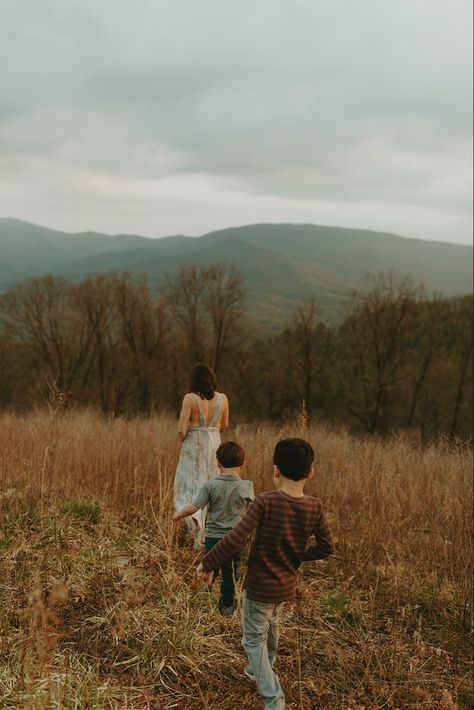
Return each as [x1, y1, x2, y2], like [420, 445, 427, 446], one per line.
[0, 410, 473, 710]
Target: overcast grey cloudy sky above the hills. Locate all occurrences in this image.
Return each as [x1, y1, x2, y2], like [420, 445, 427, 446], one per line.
[0, 0, 472, 243]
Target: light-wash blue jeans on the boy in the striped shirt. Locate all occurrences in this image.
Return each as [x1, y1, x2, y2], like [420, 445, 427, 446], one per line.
[242, 590, 285, 710]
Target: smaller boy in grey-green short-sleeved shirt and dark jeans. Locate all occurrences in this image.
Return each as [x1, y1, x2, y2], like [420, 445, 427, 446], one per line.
[173, 441, 254, 616]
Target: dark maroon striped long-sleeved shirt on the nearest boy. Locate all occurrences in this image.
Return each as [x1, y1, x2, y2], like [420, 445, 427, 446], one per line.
[202, 491, 334, 603]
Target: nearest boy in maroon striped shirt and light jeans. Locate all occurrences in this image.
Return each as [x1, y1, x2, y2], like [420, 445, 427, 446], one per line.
[196, 439, 334, 710]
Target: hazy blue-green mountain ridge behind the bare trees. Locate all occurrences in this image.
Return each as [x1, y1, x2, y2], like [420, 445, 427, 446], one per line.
[0, 219, 473, 324]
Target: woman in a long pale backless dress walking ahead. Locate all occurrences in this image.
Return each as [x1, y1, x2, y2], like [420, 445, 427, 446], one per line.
[174, 365, 229, 549]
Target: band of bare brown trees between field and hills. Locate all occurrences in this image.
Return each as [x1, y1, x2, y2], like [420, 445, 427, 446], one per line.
[0, 263, 473, 441]
